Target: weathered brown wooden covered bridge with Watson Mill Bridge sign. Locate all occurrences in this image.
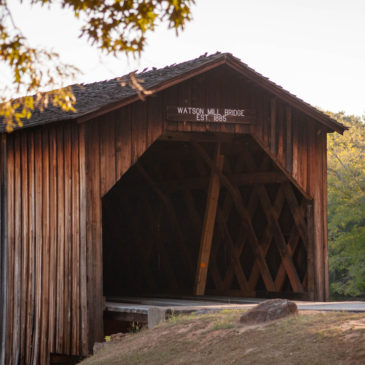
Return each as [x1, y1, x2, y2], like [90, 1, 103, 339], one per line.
[0, 53, 345, 364]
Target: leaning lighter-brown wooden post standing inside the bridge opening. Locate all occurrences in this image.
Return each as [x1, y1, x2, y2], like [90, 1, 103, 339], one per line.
[194, 143, 224, 295]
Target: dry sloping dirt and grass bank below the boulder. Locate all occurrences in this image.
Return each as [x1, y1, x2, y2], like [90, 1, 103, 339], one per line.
[82, 310, 365, 365]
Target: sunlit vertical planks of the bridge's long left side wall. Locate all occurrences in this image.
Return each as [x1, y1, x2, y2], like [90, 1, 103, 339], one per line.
[5, 123, 87, 364]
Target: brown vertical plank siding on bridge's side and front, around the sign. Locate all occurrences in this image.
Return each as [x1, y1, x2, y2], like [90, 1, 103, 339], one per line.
[4, 68, 328, 364]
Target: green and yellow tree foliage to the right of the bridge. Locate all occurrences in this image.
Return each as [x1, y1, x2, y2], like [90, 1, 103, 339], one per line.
[328, 113, 365, 296]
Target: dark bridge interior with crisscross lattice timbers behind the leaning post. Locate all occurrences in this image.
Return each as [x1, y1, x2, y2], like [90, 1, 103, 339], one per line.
[103, 138, 308, 296]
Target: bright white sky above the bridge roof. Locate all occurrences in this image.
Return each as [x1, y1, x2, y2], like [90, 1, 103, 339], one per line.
[9, 0, 365, 115]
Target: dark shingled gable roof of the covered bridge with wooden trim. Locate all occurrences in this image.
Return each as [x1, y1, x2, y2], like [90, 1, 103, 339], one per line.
[0, 53, 347, 133]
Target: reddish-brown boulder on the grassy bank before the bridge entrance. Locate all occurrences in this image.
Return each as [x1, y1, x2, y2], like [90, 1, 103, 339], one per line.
[240, 299, 298, 324]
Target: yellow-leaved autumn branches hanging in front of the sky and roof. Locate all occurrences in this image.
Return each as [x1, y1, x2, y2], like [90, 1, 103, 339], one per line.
[0, 0, 194, 131]
